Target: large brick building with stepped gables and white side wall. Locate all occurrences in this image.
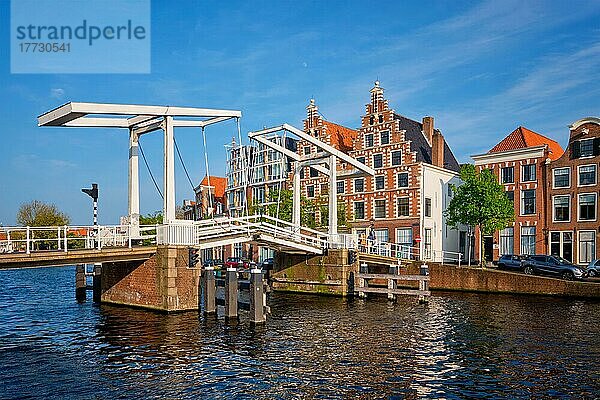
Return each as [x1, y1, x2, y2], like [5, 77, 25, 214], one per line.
[298, 82, 466, 258]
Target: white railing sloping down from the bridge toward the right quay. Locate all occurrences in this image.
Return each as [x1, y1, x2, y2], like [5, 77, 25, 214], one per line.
[358, 239, 463, 267]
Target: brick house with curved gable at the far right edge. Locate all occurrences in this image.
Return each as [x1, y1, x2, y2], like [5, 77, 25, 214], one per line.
[545, 117, 600, 265]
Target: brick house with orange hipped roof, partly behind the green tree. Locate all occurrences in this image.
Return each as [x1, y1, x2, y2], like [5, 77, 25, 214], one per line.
[472, 126, 563, 260]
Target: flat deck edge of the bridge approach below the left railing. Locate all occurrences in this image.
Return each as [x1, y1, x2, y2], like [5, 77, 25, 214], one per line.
[0, 246, 156, 269]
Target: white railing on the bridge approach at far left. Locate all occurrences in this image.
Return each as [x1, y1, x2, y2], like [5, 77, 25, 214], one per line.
[0, 225, 156, 254]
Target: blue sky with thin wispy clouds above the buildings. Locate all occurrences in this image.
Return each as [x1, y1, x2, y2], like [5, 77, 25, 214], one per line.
[0, 0, 600, 226]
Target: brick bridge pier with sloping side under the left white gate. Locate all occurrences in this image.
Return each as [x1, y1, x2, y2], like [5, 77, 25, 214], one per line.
[100, 246, 200, 312]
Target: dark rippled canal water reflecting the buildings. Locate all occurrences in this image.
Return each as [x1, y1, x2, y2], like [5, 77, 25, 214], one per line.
[0, 267, 600, 399]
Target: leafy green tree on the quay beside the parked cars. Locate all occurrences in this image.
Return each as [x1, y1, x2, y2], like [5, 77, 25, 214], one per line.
[444, 164, 515, 264]
